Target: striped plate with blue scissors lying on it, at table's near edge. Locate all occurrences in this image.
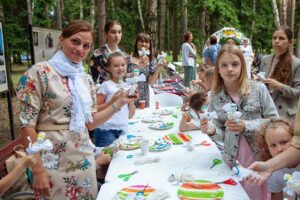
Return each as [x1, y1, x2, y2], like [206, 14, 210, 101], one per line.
[115, 185, 156, 200]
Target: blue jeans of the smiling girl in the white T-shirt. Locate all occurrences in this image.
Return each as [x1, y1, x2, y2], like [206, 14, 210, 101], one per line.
[94, 128, 123, 147]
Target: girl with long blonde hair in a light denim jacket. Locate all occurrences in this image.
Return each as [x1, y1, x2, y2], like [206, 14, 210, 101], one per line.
[201, 45, 278, 200]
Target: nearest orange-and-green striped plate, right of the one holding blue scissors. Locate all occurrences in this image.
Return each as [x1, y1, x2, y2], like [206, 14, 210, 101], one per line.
[177, 180, 224, 200]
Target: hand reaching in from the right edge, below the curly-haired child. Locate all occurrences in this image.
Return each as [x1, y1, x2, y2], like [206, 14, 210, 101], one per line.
[245, 162, 272, 185]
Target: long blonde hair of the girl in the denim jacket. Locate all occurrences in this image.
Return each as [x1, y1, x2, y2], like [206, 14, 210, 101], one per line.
[212, 45, 251, 95]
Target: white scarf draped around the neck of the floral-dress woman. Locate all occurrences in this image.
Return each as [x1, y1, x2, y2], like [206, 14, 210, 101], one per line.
[49, 50, 93, 133]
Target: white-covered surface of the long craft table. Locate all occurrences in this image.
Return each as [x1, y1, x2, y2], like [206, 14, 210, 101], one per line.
[97, 107, 249, 200]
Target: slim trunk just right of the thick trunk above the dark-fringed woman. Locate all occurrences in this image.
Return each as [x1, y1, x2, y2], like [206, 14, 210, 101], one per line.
[159, 0, 166, 51]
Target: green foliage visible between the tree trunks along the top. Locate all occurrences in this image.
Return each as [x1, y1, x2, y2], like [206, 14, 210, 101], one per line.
[1, 0, 300, 62]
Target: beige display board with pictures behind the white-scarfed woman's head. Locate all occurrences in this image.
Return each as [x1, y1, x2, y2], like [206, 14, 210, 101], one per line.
[32, 27, 61, 63]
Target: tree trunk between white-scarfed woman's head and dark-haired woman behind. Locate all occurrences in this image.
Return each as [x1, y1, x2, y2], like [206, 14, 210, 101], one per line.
[97, 0, 106, 47]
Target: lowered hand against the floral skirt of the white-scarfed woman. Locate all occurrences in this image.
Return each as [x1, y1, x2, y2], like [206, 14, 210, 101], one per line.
[32, 167, 50, 199]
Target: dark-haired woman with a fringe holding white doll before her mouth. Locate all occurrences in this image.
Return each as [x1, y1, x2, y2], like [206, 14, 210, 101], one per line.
[127, 33, 166, 107]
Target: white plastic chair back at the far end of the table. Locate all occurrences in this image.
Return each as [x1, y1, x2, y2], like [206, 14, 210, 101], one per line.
[155, 93, 183, 106]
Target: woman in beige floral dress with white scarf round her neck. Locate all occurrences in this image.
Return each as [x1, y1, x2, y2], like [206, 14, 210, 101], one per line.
[17, 21, 137, 200]
